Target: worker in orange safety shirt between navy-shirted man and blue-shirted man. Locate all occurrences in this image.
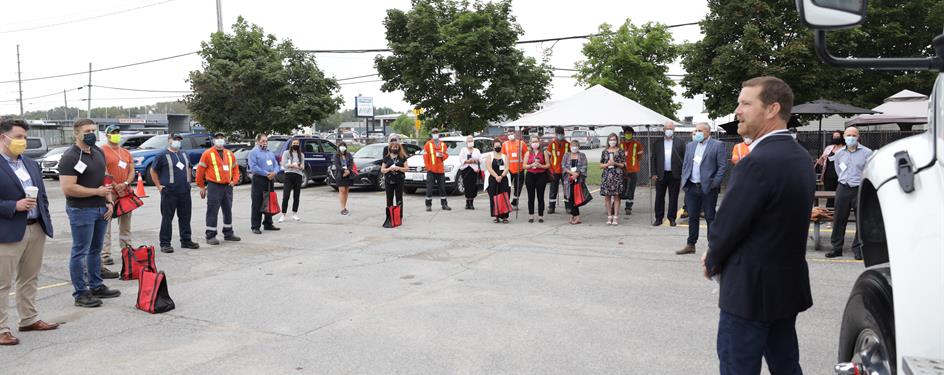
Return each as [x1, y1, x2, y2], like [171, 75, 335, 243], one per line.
[197, 133, 242, 245]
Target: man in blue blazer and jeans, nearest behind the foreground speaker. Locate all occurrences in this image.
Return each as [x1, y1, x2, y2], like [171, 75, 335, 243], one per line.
[675, 122, 728, 255]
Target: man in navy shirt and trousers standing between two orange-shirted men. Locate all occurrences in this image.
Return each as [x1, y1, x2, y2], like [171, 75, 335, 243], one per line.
[151, 134, 200, 253]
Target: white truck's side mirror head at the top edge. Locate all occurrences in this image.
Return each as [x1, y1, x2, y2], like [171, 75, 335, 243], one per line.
[796, 0, 868, 30]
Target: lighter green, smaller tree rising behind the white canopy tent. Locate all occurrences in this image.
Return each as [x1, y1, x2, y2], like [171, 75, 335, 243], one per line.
[576, 19, 682, 118]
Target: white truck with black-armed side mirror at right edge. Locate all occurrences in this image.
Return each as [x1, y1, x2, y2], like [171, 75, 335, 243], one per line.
[797, 0, 944, 375]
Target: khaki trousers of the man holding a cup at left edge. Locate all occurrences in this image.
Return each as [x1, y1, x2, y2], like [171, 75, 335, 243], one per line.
[0, 223, 46, 334]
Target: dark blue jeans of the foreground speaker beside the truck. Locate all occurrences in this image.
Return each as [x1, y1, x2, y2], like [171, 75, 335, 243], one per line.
[718, 310, 803, 375]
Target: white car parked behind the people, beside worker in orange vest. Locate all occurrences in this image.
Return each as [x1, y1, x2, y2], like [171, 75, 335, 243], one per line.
[403, 137, 493, 194]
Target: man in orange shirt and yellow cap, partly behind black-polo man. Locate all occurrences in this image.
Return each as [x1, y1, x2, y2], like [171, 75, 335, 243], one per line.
[102, 125, 135, 268]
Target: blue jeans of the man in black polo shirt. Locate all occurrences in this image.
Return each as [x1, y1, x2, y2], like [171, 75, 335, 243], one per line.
[66, 206, 108, 297]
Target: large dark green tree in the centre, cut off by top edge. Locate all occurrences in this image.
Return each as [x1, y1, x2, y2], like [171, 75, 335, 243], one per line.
[374, 0, 551, 134]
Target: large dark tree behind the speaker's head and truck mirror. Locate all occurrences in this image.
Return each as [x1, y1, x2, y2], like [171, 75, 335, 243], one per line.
[682, 0, 944, 116]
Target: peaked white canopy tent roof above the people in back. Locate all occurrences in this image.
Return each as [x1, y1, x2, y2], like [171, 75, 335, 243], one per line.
[501, 85, 678, 128]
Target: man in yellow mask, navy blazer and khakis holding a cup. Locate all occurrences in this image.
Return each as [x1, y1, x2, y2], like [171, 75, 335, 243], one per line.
[0, 120, 59, 345]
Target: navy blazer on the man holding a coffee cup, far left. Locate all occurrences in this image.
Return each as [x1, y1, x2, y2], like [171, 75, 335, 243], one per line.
[0, 156, 52, 243]
